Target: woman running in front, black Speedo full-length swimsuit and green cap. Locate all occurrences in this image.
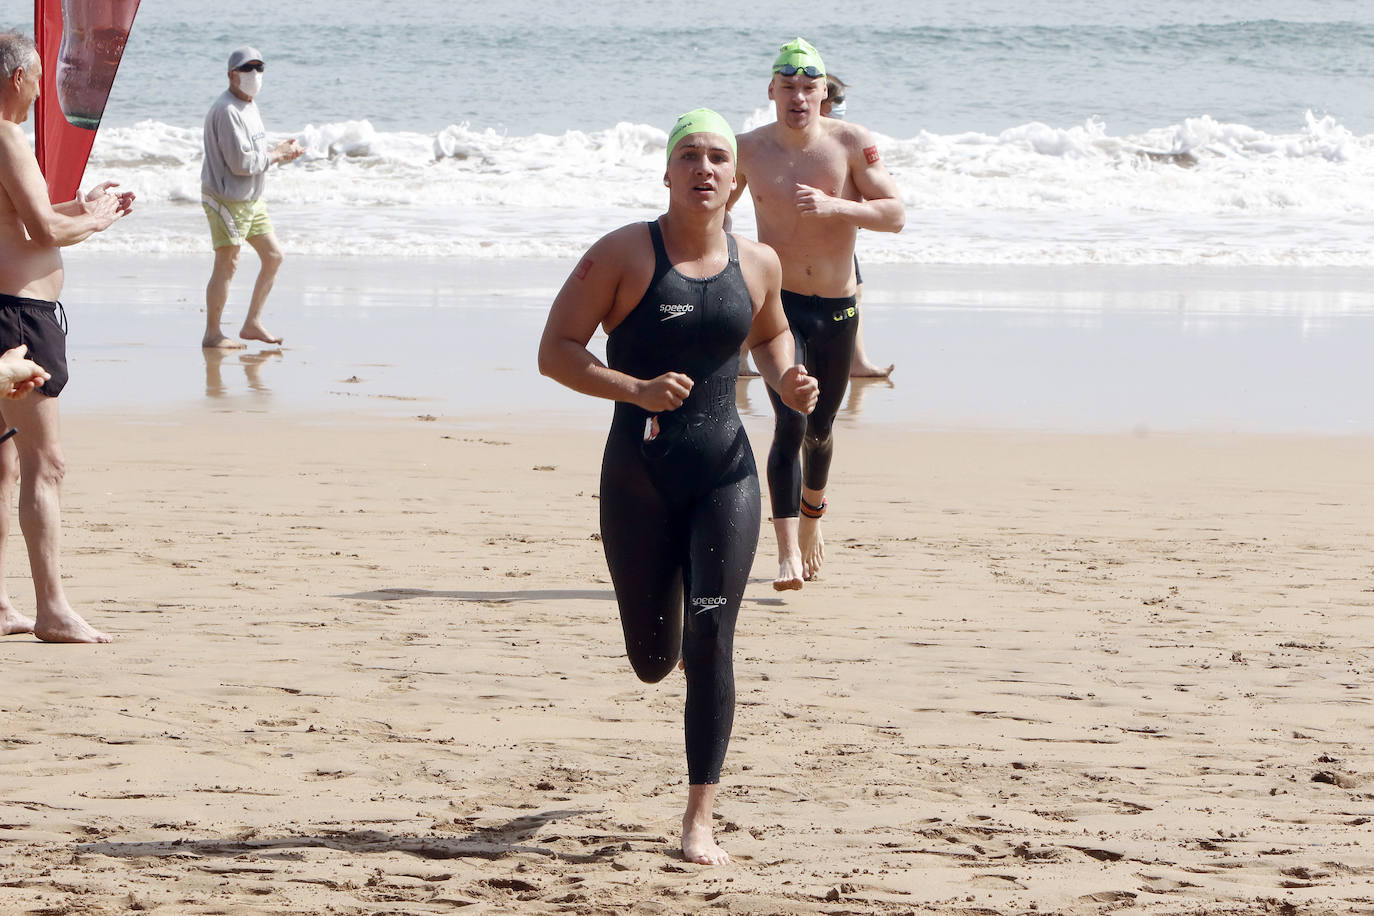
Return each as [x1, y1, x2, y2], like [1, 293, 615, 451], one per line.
[539, 108, 816, 865]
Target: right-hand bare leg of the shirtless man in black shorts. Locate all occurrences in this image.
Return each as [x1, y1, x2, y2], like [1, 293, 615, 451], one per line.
[4, 394, 111, 643]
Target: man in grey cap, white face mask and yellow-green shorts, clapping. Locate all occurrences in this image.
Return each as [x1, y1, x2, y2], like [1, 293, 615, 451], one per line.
[201, 48, 305, 349]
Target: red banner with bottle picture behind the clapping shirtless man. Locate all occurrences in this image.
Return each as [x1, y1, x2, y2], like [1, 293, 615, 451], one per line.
[33, 0, 139, 203]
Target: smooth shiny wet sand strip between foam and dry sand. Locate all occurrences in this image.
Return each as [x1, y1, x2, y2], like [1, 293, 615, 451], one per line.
[48, 249, 1374, 437]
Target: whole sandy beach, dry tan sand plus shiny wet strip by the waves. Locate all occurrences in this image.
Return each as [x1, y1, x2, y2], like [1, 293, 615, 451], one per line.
[0, 258, 1374, 916]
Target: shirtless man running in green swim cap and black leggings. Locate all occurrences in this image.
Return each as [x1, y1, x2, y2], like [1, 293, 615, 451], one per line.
[730, 38, 905, 591]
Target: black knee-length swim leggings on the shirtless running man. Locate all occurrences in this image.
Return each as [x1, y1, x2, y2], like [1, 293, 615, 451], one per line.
[768, 290, 859, 518]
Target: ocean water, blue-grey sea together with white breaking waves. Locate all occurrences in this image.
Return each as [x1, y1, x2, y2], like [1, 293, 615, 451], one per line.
[16, 0, 1374, 268]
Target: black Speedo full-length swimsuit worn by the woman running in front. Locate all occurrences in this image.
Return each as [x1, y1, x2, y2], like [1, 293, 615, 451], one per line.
[600, 222, 760, 786]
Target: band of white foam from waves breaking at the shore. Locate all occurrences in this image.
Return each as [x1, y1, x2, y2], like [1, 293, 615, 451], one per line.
[77, 111, 1374, 266]
